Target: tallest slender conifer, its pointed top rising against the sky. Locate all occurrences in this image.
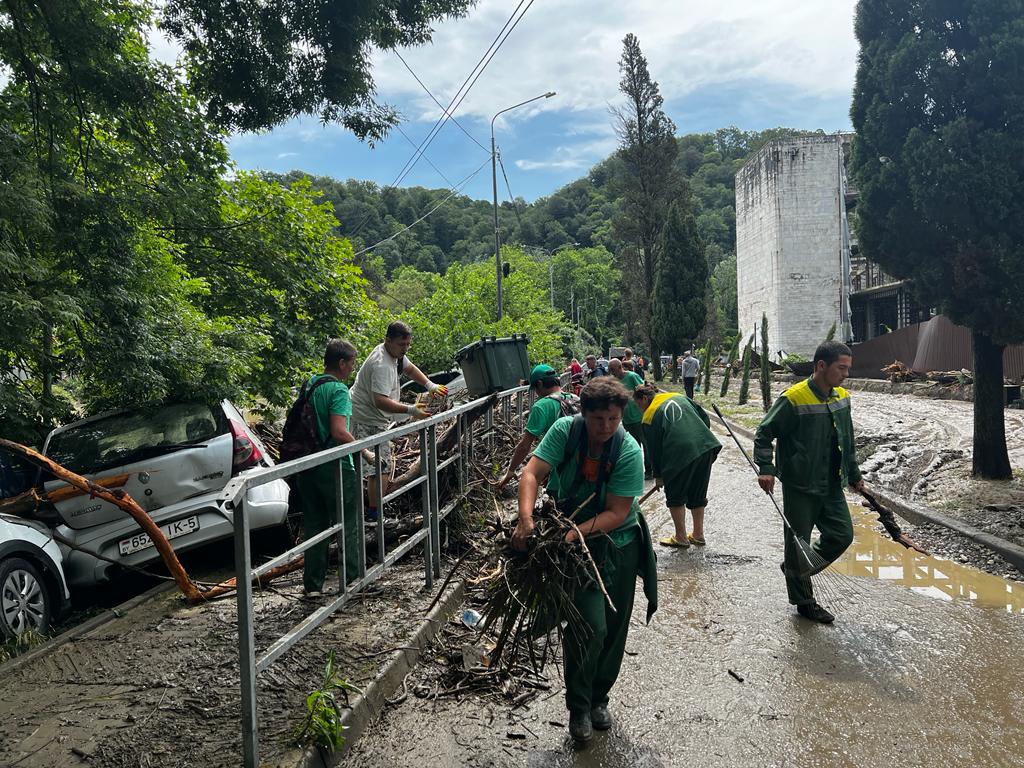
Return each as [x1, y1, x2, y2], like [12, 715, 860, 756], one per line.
[613, 34, 684, 379]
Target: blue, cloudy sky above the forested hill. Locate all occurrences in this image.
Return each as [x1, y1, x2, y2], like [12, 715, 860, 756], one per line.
[192, 0, 857, 201]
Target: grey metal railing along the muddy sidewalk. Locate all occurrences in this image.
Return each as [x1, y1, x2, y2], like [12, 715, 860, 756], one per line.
[220, 386, 534, 768]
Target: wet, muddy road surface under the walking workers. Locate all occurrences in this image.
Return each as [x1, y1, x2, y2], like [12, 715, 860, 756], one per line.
[346, 440, 1024, 768]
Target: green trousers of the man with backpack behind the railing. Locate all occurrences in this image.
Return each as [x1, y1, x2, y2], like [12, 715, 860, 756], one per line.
[298, 464, 362, 592]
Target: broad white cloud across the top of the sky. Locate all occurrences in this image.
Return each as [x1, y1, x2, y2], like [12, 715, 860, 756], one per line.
[374, 0, 857, 122]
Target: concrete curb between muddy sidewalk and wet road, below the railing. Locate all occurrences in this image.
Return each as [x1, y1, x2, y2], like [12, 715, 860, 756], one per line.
[279, 582, 466, 768]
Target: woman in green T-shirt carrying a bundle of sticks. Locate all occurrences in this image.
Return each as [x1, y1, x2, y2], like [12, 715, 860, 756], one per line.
[512, 376, 657, 741]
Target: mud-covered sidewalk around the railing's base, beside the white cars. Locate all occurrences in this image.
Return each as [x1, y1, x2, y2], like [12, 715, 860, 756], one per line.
[0, 555, 452, 768]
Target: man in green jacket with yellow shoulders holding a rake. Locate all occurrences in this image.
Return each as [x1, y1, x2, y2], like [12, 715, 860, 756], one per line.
[754, 341, 864, 624]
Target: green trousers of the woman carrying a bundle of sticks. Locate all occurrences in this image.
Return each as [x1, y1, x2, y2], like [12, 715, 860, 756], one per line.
[565, 535, 641, 715]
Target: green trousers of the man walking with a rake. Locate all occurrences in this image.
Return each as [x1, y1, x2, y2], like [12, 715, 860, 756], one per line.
[782, 484, 853, 605]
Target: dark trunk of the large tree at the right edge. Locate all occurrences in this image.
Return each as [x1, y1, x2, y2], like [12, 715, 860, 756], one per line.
[971, 331, 1013, 480]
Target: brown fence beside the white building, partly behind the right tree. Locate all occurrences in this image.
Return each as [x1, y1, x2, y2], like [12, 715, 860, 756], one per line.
[851, 314, 1024, 382]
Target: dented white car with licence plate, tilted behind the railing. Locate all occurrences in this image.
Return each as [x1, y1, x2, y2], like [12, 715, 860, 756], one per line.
[43, 400, 289, 587]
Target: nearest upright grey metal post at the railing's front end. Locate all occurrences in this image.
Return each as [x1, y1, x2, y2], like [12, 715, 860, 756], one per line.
[231, 495, 259, 768]
